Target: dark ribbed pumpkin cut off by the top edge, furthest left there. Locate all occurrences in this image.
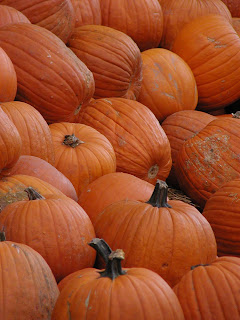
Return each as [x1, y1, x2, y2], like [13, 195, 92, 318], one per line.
[0, 0, 75, 43]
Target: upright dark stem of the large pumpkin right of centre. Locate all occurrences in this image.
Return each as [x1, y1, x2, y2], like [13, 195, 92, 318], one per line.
[146, 180, 171, 208]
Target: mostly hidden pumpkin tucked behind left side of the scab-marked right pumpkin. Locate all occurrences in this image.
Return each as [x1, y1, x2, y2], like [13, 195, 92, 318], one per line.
[161, 110, 216, 186]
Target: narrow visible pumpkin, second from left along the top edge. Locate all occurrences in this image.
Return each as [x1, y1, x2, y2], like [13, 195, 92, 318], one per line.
[71, 0, 102, 28]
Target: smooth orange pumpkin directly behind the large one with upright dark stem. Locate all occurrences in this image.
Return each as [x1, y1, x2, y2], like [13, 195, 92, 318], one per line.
[78, 172, 154, 225]
